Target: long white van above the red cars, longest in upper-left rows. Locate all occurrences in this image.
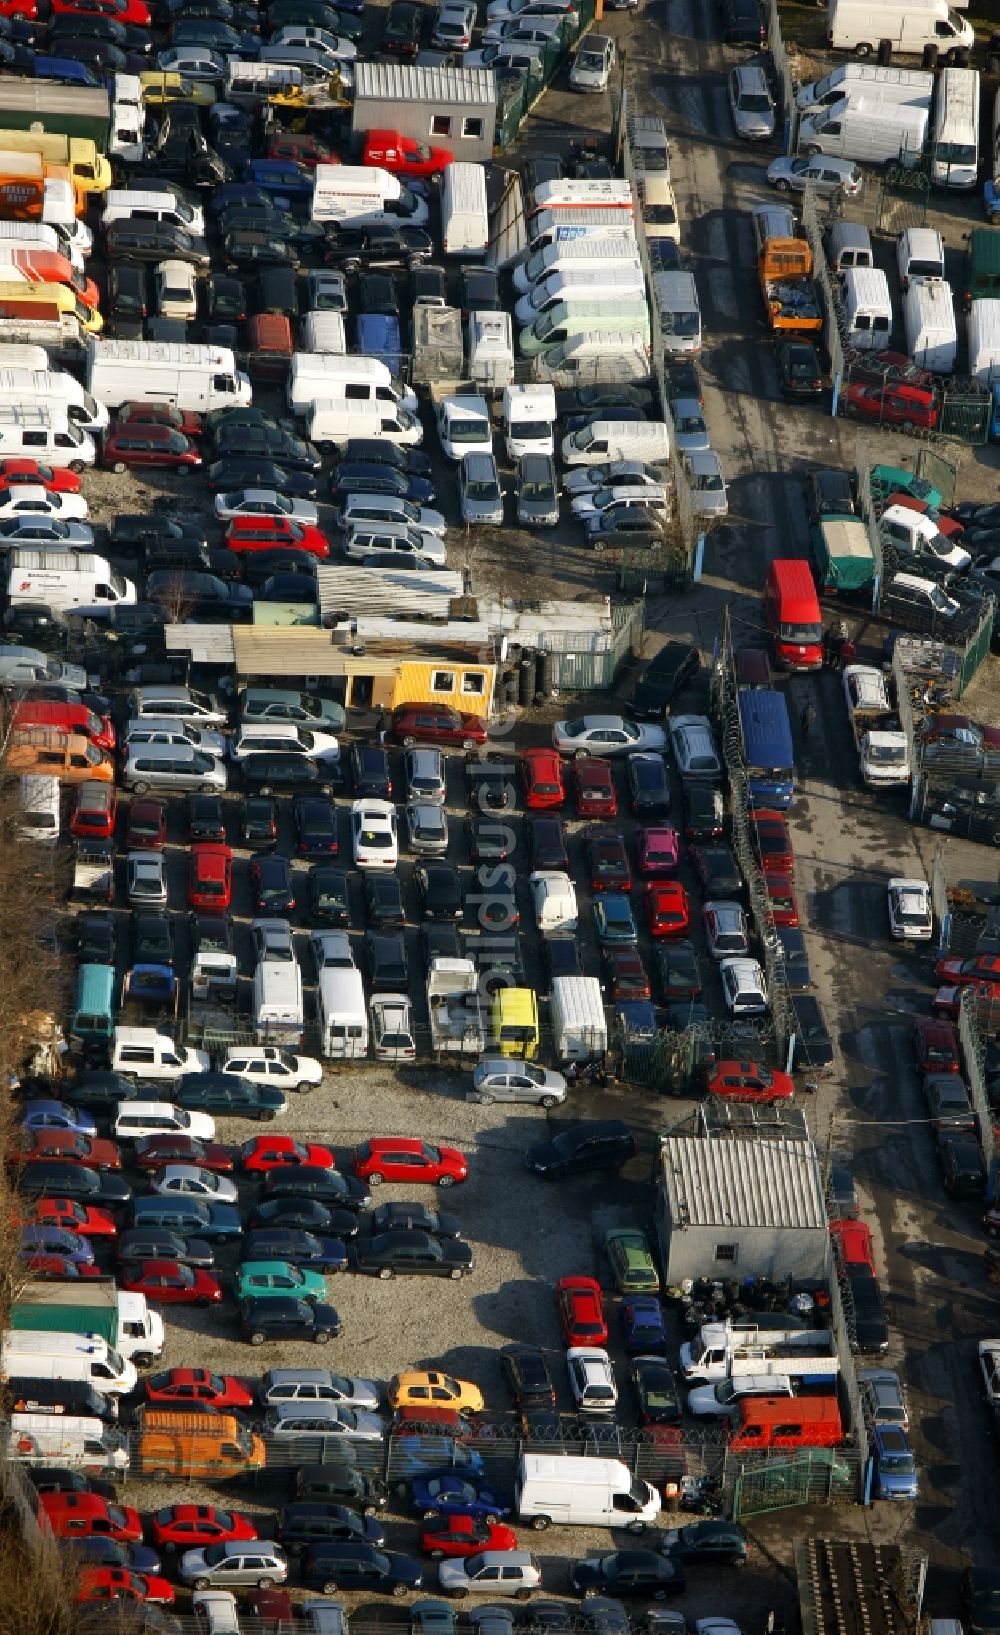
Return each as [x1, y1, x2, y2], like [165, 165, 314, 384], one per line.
[87, 338, 250, 414]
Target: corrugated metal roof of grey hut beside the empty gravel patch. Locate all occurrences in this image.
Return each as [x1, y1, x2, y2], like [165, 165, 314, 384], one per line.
[662, 1136, 827, 1231]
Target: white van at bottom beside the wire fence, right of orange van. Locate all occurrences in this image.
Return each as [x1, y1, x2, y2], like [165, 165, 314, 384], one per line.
[515, 1454, 660, 1532]
